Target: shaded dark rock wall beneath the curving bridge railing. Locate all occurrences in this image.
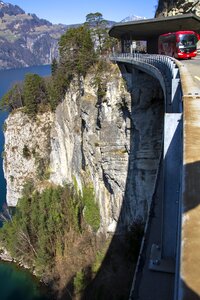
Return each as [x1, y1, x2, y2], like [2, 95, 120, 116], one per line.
[121, 71, 164, 224]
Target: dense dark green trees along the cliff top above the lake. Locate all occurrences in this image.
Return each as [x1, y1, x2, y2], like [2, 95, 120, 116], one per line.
[1, 26, 97, 117]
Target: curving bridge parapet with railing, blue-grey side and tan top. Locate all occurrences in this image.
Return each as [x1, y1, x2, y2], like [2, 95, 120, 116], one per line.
[111, 53, 200, 300]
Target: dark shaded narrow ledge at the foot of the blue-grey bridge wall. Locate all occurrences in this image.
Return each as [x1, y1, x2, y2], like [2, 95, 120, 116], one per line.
[129, 163, 174, 300]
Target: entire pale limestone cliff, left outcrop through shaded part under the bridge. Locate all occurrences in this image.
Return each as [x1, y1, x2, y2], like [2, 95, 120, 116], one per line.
[4, 65, 163, 232]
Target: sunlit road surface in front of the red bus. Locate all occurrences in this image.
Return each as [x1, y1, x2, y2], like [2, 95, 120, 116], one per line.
[181, 55, 200, 88]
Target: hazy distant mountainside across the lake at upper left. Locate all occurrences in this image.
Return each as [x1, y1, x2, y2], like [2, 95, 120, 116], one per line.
[0, 1, 67, 69]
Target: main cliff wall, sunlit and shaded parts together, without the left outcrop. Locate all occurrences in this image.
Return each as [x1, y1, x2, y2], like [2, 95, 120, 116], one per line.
[48, 67, 164, 231]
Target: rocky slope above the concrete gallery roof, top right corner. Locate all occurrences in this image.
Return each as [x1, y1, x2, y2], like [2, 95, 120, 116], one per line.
[156, 0, 200, 17]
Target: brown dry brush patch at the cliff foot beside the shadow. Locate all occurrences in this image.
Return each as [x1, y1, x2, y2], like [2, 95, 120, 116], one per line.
[53, 231, 106, 299]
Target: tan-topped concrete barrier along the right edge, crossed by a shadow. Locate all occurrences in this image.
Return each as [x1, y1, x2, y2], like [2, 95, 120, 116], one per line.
[179, 66, 200, 300]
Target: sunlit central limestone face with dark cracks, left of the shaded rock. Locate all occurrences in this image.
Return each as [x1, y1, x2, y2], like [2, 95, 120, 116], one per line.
[50, 67, 131, 230]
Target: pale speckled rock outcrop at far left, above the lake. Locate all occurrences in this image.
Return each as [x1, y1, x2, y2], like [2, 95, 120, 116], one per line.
[3, 111, 53, 206]
